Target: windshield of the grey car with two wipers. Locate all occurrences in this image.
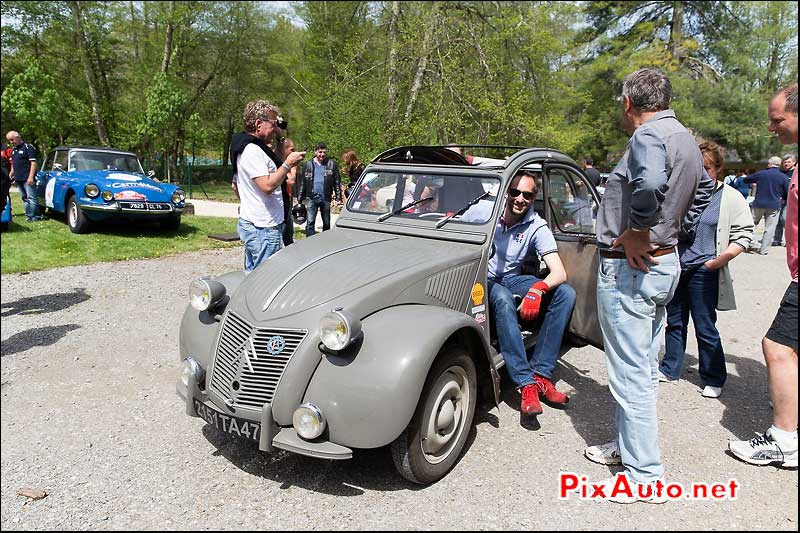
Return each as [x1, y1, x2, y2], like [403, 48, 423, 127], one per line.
[347, 172, 500, 224]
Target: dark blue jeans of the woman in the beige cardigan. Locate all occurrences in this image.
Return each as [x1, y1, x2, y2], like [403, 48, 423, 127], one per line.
[660, 267, 728, 387]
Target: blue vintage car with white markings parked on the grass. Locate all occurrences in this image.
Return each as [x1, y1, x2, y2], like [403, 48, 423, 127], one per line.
[37, 146, 186, 233]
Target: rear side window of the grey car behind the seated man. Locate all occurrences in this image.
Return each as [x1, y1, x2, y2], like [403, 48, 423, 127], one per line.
[548, 168, 597, 235]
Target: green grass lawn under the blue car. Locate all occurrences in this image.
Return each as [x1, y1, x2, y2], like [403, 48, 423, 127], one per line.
[0, 191, 241, 274]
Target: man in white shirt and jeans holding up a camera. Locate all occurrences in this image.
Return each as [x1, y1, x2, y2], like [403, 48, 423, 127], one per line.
[231, 100, 306, 272]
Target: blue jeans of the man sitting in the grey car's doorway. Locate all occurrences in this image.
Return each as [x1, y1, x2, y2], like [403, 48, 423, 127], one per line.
[488, 276, 575, 387]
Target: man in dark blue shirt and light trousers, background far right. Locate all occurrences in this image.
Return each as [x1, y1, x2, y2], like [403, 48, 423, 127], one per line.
[744, 156, 789, 255]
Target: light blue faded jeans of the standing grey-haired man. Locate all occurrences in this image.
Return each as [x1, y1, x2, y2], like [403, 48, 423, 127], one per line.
[597, 253, 680, 483]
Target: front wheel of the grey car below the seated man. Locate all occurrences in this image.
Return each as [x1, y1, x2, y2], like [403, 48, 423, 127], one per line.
[391, 345, 477, 484]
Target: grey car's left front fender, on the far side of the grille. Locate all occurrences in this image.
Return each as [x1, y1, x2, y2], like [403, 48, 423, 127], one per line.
[179, 271, 245, 370]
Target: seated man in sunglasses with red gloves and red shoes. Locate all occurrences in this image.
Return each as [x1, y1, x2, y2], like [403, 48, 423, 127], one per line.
[488, 172, 575, 415]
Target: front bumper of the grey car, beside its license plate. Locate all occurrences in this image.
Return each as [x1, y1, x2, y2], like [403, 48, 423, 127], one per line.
[175, 368, 353, 459]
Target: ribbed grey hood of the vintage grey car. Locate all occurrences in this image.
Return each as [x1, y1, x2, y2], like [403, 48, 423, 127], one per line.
[238, 228, 481, 321]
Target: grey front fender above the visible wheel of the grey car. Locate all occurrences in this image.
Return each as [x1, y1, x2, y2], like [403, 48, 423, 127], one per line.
[304, 305, 496, 448]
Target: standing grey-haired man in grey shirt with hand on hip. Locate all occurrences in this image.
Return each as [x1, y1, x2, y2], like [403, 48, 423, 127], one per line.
[585, 68, 714, 502]
